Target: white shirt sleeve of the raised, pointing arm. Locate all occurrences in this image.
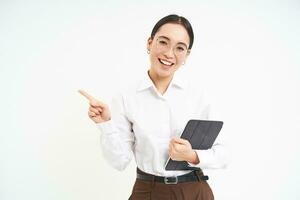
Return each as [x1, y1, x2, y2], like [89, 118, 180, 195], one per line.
[97, 95, 134, 171]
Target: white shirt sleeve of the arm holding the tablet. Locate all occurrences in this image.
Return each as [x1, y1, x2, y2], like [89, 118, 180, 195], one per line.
[188, 92, 230, 169]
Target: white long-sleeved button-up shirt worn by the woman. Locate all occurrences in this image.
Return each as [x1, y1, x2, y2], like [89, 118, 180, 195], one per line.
[97, 72, 228, 176]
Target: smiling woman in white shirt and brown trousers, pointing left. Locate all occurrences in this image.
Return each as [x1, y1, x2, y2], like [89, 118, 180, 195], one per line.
[80, 15, 226, 200]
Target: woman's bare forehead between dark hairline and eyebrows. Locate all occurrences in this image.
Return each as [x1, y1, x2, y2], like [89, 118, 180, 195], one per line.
[155, 23, 190, 44]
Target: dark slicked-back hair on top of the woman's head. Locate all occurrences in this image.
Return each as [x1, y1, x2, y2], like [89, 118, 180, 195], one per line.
[151, 14, 194, 49]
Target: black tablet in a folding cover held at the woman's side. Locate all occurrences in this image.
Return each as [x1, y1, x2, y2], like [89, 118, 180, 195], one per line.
[165, 119, 223, 170]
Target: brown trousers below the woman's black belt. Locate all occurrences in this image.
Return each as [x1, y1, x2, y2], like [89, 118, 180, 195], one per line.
[129, 170, 214, 200]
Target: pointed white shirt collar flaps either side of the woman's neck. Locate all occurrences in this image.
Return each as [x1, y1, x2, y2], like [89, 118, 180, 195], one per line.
[137, 71, 186, 92]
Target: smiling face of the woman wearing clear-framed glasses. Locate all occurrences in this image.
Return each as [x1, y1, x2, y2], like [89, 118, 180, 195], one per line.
[147, 23, 190, 78]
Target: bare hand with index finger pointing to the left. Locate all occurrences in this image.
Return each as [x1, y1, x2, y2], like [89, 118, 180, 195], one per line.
[78, 90, 111, 123]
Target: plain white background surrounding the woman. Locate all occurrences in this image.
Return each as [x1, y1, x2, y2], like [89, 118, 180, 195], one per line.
[0, 0, 300, 200]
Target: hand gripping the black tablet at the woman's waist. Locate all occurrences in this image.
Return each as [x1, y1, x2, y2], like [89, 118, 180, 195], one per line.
[169, 138, 199, 164]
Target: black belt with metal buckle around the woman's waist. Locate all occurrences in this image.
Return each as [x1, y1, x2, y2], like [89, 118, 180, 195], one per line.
[136, 169, 208, 184]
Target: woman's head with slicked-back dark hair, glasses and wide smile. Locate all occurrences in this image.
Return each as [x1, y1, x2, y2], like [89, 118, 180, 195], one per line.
[147, 15, 194, 88]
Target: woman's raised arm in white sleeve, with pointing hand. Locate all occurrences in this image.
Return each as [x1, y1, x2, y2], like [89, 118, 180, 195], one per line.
[79, 90, 134, 170]
